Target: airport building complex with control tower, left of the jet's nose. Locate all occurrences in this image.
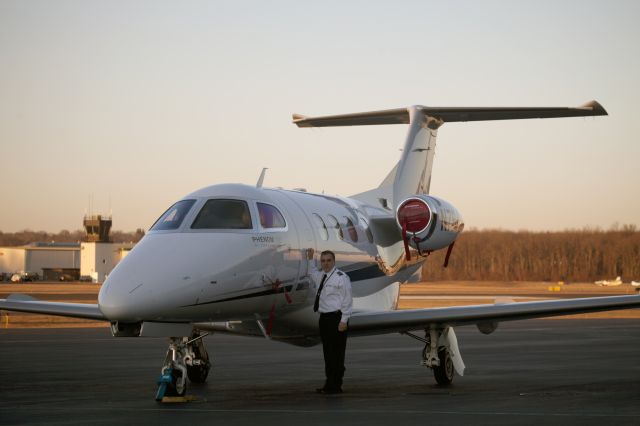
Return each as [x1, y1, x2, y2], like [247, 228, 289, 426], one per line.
[0, 215, 134, 282]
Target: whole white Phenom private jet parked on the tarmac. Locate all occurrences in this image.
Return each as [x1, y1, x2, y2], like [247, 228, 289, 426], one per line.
[0, 101, 640, 399]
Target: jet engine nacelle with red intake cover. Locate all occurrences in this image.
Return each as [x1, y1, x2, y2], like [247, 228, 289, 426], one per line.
[396, 195, 464, 260]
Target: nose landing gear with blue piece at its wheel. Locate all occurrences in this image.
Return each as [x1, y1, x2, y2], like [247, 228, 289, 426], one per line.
[156, 332, 211, 401]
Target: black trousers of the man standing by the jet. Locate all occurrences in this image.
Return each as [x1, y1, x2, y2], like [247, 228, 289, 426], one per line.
[319, 311, 347, 389]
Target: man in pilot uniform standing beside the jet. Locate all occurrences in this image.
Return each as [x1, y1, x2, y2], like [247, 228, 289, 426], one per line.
[307, 249, 353, 394]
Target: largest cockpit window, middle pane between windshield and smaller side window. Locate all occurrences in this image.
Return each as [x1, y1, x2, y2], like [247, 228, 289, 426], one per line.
[191, 199, 252, 229]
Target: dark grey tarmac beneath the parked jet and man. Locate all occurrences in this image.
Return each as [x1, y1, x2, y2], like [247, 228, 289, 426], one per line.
[0, 319, 640, 426]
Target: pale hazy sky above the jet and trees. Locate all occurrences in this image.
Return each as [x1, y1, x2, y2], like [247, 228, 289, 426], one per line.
[0, 0, 640, 232]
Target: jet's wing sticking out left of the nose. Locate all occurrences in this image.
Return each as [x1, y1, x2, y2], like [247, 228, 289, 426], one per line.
[0, 294, 108, 321]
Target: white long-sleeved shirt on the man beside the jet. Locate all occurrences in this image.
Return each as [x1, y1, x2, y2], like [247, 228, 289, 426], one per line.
[309, 261, 353, 323]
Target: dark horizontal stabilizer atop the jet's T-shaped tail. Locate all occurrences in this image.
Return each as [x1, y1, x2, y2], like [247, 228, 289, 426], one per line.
[293, 101, 607, 127]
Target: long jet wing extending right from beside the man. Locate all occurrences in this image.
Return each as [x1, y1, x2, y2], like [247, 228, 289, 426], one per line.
[349, 295, 640, 335]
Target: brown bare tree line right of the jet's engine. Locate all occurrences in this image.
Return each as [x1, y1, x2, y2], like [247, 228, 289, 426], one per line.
[423, 225, 640, 282]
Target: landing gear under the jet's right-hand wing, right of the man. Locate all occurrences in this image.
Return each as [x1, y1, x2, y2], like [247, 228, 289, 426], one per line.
[404, 327, 464, 386]
